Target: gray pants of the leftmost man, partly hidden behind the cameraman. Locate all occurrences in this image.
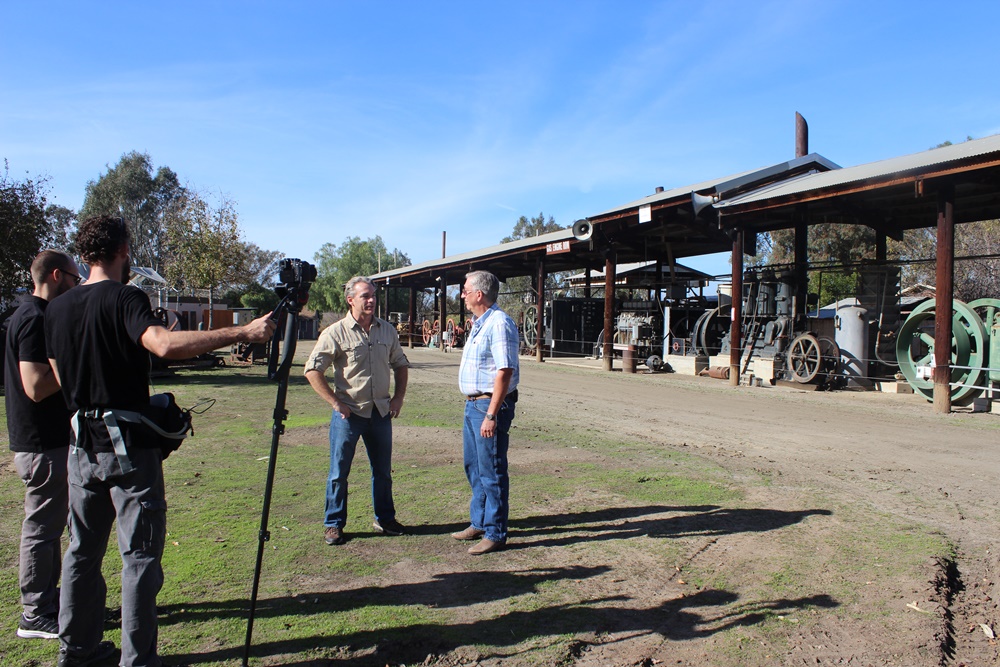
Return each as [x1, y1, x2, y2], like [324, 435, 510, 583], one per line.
[14, 447, 69, 616]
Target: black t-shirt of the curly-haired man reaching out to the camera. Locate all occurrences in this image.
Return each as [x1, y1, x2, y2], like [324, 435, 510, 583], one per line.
[45, 280, 163, 420]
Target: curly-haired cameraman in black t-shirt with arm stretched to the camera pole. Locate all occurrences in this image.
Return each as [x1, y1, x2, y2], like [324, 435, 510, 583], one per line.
[45, 216, 275, 667]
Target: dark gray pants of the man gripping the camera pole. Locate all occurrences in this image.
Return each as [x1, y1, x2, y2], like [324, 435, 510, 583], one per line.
[59, 447, 167, 667]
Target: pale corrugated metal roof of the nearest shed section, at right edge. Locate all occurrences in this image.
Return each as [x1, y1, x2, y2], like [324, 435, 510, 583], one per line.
[714, 134, 1000, 211]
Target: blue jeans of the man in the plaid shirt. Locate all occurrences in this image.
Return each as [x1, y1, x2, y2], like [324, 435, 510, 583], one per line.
[462, 396, 514, 542]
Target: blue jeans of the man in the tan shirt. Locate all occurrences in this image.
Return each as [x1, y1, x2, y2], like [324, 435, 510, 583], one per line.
[323, 408, 396, 528]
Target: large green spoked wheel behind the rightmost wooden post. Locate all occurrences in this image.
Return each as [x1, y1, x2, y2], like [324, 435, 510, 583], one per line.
[896, 299, 988, 405]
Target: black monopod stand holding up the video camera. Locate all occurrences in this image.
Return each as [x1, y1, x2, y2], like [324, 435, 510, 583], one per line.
[243, 283, 309, 667]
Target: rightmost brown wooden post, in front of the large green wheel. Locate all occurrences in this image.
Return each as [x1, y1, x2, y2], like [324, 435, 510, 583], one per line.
[934, 184, 955, 414]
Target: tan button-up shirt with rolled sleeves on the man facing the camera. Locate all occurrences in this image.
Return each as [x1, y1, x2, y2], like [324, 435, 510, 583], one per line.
[304, 313, 410, 418]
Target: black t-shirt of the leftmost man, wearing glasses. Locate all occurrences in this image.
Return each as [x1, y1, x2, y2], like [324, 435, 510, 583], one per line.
[4, 295, 70, 453]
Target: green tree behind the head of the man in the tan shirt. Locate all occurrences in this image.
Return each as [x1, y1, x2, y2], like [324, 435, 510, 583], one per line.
[309, 236, 410, 313]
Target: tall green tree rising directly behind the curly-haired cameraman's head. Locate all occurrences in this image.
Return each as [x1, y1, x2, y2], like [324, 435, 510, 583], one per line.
[79, 151, 185, 273]
